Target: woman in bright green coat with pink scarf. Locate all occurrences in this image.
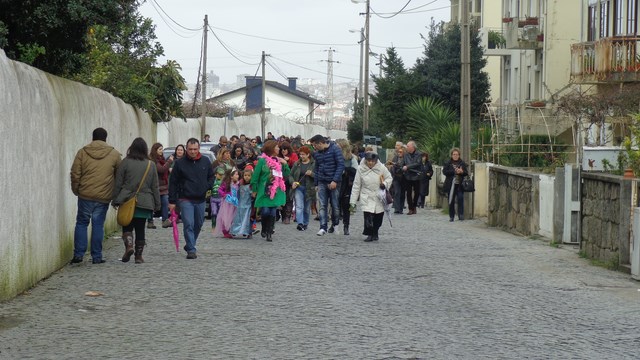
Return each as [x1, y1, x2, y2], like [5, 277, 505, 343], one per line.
[251, 140, 290, 241]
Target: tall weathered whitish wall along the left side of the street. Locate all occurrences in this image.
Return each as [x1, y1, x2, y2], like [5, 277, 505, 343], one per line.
[0, 50, 156, 300]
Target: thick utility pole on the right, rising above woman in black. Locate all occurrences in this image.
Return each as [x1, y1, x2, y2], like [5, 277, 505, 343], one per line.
[460, 1, 471, 163]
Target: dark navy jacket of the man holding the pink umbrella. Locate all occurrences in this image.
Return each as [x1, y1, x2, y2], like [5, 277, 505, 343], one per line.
[169, 155, 214, 204]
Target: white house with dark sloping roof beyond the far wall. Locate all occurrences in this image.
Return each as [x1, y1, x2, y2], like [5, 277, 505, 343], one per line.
[207, 76, 325, 123]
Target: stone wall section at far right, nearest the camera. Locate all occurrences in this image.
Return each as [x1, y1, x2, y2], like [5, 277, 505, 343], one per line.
[580, 172, 633, 265]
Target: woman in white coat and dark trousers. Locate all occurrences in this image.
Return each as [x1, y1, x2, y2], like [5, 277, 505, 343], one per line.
[350, 152, 393, 242]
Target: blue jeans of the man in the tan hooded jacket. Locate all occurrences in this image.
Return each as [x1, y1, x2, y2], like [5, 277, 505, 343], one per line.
[73, 198, 109, 260]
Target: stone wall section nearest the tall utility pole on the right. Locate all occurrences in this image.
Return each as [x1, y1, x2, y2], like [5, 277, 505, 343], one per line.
[487, 166, 540, 236]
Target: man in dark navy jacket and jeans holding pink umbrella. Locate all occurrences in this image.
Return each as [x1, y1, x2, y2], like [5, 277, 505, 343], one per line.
[169, 138, 214, 259]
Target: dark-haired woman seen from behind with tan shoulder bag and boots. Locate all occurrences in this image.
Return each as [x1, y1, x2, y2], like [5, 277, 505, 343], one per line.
[112, 138, 161, 264]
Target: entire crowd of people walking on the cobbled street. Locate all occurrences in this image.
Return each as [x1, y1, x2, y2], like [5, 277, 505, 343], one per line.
[71, 128, 467, 264]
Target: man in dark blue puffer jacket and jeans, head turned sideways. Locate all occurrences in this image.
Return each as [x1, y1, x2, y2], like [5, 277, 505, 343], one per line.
[309, 134, 344, 236]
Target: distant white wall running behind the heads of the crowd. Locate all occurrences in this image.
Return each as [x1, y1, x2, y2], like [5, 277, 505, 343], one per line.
[158, 114, 347, 146]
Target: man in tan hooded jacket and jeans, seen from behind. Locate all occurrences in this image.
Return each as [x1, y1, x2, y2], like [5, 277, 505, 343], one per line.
[70, 128, 121, 264]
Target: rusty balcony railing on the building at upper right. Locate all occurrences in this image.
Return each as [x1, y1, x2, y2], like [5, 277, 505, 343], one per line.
[571, 36, 640, 83]
